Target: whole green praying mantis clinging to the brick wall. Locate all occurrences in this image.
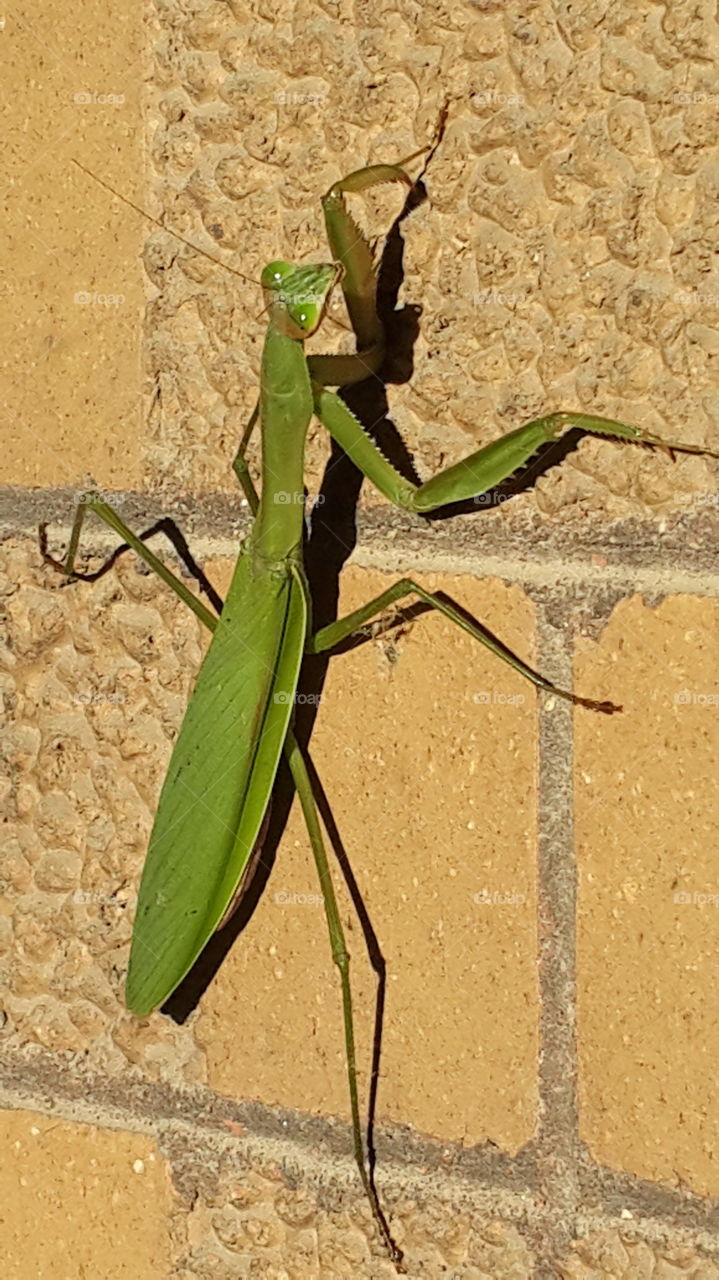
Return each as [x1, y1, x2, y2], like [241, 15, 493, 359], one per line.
[43, 127, 719, 1271]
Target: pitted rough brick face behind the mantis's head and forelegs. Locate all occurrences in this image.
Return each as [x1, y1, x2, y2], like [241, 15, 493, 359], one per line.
[136, 0, 719, 517]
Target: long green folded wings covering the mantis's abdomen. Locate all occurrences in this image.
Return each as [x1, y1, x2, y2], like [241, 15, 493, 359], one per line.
[125, 555, 308, 1016]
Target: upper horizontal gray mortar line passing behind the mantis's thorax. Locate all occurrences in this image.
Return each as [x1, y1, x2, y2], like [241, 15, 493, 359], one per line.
[0, 486, 719, 596]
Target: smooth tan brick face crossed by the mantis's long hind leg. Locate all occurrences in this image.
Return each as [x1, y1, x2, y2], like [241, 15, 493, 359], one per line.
[198, 570, 537, 1151]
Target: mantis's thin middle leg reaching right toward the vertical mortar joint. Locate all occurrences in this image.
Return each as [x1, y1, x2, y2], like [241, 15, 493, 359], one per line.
[307, 577, 622, 716]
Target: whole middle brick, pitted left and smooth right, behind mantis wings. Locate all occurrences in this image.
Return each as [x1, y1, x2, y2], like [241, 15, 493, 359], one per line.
[6, 540, 537, 1149]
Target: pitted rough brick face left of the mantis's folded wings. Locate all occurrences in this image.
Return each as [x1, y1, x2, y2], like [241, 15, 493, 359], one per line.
[0, 543, 202, 1078]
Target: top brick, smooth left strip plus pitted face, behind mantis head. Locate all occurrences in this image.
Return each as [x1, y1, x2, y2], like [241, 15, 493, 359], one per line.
[6, 0, 719, 515]
